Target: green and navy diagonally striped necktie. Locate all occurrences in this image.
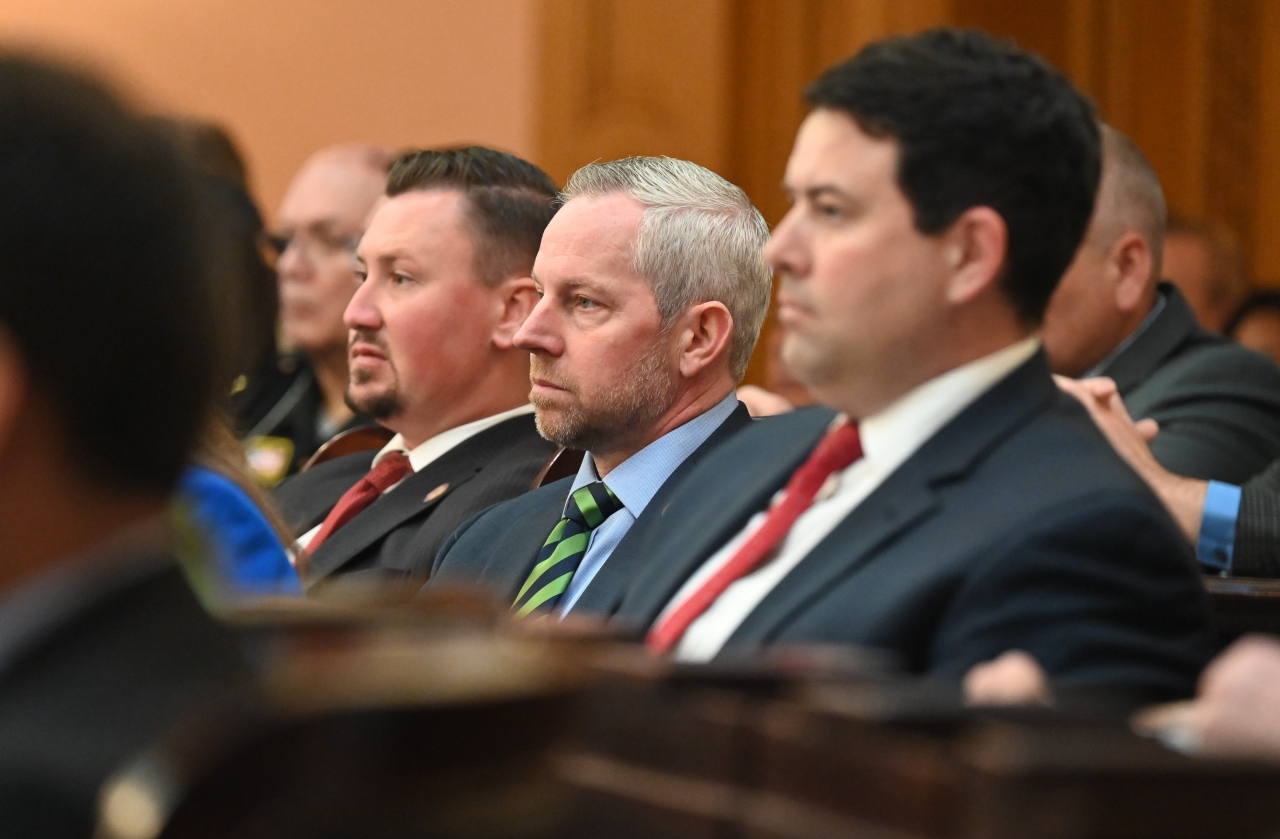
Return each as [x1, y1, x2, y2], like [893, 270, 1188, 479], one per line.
[511, 480, 625, 617]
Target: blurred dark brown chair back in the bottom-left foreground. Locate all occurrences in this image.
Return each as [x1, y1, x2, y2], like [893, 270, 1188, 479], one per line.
[96, 596, 580, 839]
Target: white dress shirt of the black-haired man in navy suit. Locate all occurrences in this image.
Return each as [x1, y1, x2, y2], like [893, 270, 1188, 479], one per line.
[658, 337, 1039, 662]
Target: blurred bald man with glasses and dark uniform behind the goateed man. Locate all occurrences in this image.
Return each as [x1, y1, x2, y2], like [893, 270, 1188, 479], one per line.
[236, 143, 390, 485]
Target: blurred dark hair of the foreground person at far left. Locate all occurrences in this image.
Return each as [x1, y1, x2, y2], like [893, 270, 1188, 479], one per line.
[0, 55, 214, 493]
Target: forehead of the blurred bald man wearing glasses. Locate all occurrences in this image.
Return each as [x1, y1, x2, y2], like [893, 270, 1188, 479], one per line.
[280, 158, 385, 227]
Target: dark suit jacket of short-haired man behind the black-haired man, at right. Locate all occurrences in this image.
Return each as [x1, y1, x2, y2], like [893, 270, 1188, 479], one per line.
[1102, 283, 1280, 484]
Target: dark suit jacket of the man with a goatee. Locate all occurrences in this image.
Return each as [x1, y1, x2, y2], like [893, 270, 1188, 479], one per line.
[276, 414, 556, 592]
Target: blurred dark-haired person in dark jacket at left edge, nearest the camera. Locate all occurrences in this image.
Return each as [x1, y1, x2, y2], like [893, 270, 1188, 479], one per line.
[0, 58, 257, 838]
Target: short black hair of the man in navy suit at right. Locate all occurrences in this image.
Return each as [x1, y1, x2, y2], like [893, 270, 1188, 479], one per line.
[805, 28, 1101, 324]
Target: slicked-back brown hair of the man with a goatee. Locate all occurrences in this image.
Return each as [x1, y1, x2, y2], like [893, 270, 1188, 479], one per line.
[387, 146, 556, 284]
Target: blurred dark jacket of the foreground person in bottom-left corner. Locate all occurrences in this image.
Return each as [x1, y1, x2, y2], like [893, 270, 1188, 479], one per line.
[0, 556, 253, 839]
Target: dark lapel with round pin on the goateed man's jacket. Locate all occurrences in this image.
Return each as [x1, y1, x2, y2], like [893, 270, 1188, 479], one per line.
[306, 416, 527, 585]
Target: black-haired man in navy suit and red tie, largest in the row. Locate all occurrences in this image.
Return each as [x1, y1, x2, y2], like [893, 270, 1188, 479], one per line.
[614, 29, 1210, 699]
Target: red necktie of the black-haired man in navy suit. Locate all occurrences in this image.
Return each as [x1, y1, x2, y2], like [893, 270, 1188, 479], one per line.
[645, 420, 863, 655]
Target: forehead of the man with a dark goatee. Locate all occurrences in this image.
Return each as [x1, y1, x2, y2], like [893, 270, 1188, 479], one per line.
[358, 190, 471, 260]
